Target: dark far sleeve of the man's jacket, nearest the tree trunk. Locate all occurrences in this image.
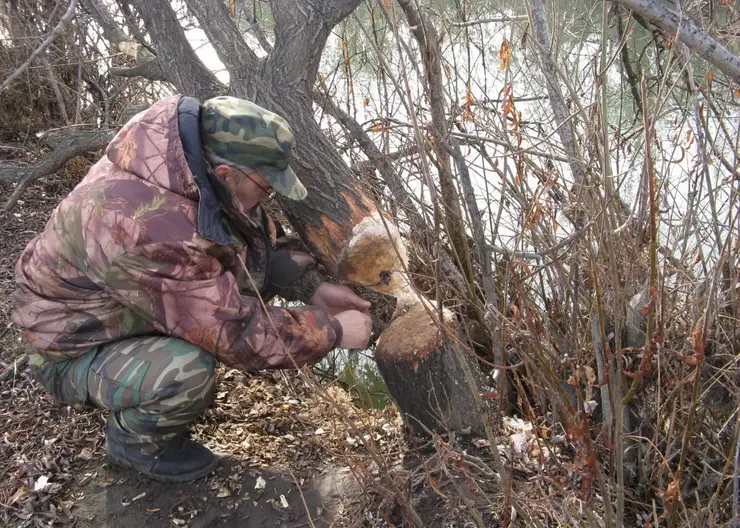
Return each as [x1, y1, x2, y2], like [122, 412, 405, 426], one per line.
[267, 237, 326, 304]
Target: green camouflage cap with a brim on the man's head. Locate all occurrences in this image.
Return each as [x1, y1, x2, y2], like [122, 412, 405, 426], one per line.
[200, 96, 308, 201]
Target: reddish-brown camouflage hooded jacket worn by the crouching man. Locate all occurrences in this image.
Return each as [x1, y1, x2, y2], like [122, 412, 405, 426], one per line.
[13, 96, 341, 372]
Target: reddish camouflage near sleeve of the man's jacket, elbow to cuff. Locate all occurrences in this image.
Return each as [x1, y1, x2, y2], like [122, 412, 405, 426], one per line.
[105, 242, 342, 372]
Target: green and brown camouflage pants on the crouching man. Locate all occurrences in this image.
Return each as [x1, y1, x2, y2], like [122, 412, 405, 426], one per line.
[29, 337, 216, 453]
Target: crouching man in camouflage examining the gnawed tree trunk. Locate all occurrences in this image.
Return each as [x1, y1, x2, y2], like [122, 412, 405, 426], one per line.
[13, 96, 371, 481]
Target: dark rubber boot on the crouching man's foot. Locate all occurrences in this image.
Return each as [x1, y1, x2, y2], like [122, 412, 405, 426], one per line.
[106, 421, 218, 482]
